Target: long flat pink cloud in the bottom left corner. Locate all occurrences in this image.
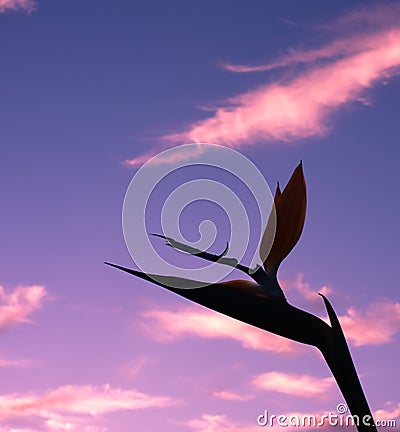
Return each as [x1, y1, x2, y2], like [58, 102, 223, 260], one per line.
[0, 385, 173, 431]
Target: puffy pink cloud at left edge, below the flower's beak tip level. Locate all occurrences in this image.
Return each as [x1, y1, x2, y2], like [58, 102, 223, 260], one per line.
[0, 285, 47, 331]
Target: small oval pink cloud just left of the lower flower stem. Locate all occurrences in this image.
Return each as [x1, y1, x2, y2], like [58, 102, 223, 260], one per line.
[253, 372, 335, 398]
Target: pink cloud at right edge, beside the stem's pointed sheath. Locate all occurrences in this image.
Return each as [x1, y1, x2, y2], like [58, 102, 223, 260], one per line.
[339, 302, 400, 346]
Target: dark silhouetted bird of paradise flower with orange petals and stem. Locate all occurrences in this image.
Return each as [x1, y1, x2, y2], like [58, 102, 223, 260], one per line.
[106, 162, 377, 432]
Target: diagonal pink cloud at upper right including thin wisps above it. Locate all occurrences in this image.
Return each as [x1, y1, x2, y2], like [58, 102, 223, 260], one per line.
[127, 5, 400, 165]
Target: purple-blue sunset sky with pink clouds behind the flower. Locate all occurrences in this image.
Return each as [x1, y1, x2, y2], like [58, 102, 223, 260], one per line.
[0, 0, 400, 432]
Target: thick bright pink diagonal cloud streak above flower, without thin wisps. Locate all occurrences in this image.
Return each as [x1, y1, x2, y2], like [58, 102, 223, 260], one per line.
[166, 29, 400, 147]
